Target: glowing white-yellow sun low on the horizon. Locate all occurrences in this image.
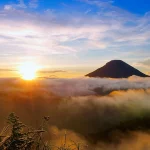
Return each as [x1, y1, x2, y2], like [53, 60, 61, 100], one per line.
[18, 62, 39, 80]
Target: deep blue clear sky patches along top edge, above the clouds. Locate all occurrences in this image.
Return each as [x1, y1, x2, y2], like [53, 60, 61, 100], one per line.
[1, 0, 150, 15]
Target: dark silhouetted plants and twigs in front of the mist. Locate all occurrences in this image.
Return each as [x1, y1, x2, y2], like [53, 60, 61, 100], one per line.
[0, 113, 85, 150]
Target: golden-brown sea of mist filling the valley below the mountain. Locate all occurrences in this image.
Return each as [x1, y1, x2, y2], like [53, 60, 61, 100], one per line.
[0, 76, 150, 150]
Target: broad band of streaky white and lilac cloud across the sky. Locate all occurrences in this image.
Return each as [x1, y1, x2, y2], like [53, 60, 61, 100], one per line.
[0, 0, 150, 64]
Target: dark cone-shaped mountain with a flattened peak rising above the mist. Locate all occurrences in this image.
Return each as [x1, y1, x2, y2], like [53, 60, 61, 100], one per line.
[86, 60, 149, 78]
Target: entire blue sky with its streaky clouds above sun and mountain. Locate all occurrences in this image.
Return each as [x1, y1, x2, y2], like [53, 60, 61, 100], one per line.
[0, 0, 150, 75]
